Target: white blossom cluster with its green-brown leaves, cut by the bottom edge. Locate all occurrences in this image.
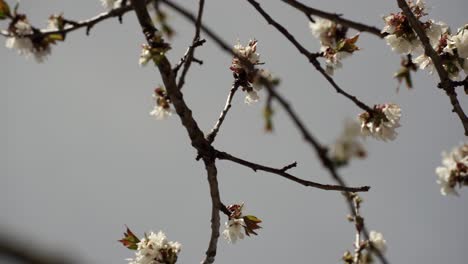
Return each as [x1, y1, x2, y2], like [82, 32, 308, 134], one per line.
[119, 228, 182, 264]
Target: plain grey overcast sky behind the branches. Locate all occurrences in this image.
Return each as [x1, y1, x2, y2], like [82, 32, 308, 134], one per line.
[0, 0, 468, 264]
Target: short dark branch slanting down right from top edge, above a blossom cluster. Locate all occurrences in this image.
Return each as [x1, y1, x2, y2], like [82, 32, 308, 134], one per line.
[282, 0, 385, 38]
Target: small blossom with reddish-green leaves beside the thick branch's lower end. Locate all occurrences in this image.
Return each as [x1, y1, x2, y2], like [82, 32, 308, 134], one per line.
[223, 203, 262, 244]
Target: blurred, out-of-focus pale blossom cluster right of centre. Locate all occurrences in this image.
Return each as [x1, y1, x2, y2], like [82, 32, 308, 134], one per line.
[330, 120, 366, 166]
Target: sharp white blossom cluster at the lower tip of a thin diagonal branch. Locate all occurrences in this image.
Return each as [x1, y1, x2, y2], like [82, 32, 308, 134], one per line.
[359, 104, 401, 141]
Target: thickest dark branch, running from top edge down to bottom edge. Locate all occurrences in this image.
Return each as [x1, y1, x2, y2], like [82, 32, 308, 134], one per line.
[132, 0, 222, 263]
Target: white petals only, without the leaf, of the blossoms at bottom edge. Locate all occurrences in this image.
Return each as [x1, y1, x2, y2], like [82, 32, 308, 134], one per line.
[129, 231, 182, 264]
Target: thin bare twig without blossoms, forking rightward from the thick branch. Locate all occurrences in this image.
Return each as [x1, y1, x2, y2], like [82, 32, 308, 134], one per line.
[216, 151, 370, 192]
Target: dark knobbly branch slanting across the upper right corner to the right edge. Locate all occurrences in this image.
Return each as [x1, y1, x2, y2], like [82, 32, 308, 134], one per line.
[397, 0, 468, 136]
